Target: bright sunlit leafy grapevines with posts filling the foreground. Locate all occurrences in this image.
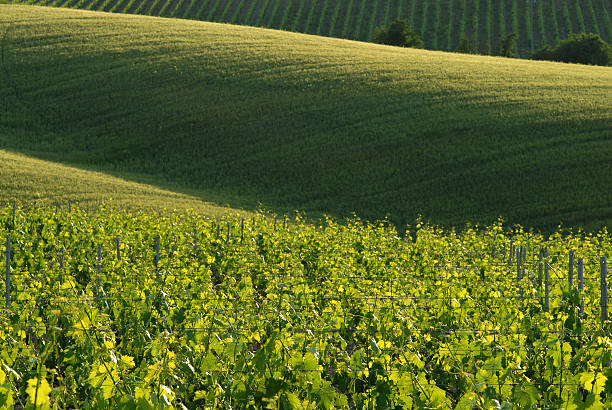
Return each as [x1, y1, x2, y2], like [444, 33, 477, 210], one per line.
[0, 204, 612, 409]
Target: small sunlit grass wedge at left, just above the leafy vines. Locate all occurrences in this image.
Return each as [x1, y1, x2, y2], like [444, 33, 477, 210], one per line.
[0, 150, 245, 217]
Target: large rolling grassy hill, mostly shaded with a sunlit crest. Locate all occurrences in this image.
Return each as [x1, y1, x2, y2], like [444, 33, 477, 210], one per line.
[0, 5, 612, 228]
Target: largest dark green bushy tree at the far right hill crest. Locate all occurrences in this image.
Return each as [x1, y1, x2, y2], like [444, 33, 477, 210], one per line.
[531, 33, 612, 66]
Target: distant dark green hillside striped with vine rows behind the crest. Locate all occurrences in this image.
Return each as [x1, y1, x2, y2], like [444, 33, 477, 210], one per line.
[9, 0, 612, 56]
